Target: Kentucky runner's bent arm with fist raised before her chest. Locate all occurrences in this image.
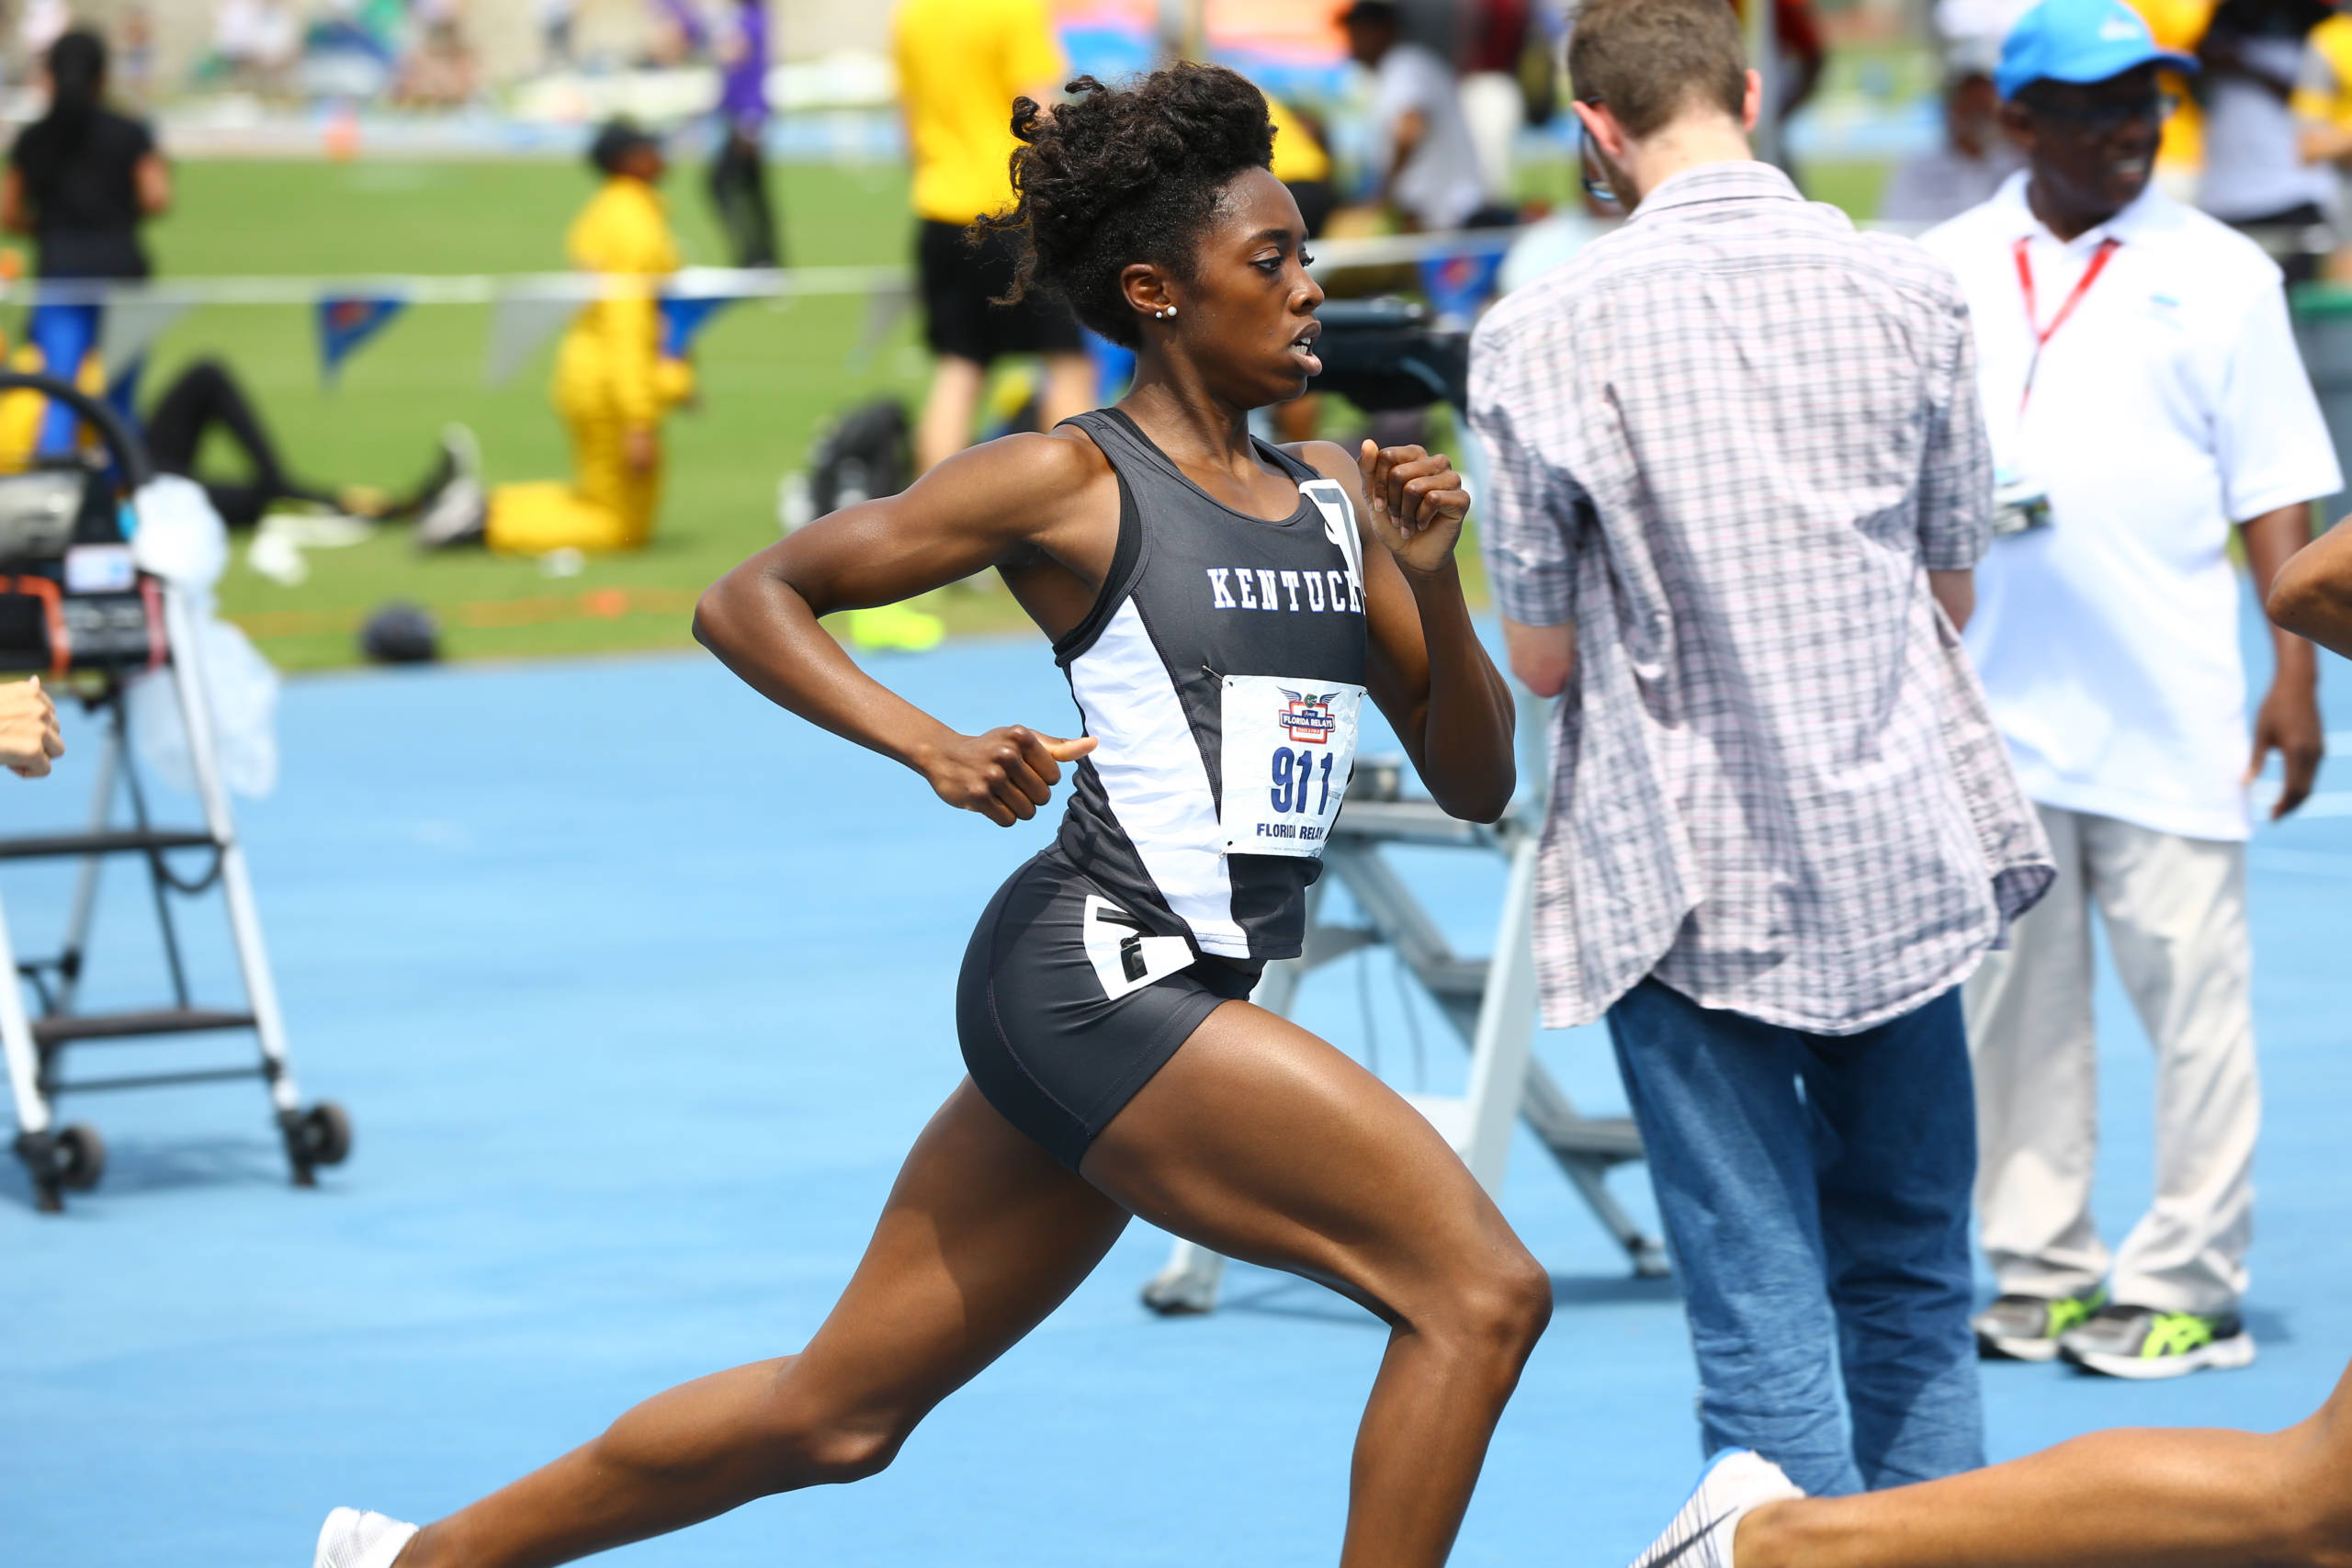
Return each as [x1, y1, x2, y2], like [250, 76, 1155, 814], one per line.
[1296, 432, 1517, 823]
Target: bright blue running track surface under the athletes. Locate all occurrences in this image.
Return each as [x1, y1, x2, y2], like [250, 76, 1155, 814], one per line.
[0, 615, 2352, 1568]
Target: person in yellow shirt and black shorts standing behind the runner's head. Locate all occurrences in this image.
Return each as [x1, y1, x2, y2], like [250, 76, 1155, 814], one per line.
[891, 0, 1096, 470]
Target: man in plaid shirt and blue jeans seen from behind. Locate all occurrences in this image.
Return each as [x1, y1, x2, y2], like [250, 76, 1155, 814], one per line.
[1470, 0, 2051, 1495]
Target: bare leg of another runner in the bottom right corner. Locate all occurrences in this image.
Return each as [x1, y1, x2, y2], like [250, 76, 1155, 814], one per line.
[1734, 1373, 2352, 1568]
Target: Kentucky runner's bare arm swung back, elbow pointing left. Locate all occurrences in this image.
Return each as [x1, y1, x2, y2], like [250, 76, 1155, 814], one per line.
[694, 423, 1120, 828]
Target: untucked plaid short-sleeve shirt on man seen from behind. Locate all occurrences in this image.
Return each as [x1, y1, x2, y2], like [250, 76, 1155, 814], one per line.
[1470, 163, 2053, 1034]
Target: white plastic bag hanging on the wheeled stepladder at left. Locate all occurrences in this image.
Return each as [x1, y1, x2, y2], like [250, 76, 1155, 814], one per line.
[125, 475, 277, 799]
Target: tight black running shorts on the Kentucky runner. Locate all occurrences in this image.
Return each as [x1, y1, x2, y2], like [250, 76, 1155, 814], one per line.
[955, 849, 1263, 1170]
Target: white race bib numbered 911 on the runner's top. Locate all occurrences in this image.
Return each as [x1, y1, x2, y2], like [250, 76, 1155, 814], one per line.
[1218, 674, 1364, 858]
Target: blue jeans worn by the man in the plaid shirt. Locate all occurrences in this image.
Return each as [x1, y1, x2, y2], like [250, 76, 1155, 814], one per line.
[1609, 980, 1985, 1495]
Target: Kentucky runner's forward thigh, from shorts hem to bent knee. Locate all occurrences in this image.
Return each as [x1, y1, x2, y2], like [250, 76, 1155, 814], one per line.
[1082, 1001, 1524, 1321]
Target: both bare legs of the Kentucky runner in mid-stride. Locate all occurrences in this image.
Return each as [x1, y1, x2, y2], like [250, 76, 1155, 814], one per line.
[400, 1001, 1553, 1568]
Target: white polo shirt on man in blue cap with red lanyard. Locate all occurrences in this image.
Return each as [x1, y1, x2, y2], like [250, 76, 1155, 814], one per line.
[1922, 174, 2343, 840]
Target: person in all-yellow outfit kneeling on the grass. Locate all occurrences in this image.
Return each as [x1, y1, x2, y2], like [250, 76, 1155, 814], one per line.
[416, 120, 694, 555]
